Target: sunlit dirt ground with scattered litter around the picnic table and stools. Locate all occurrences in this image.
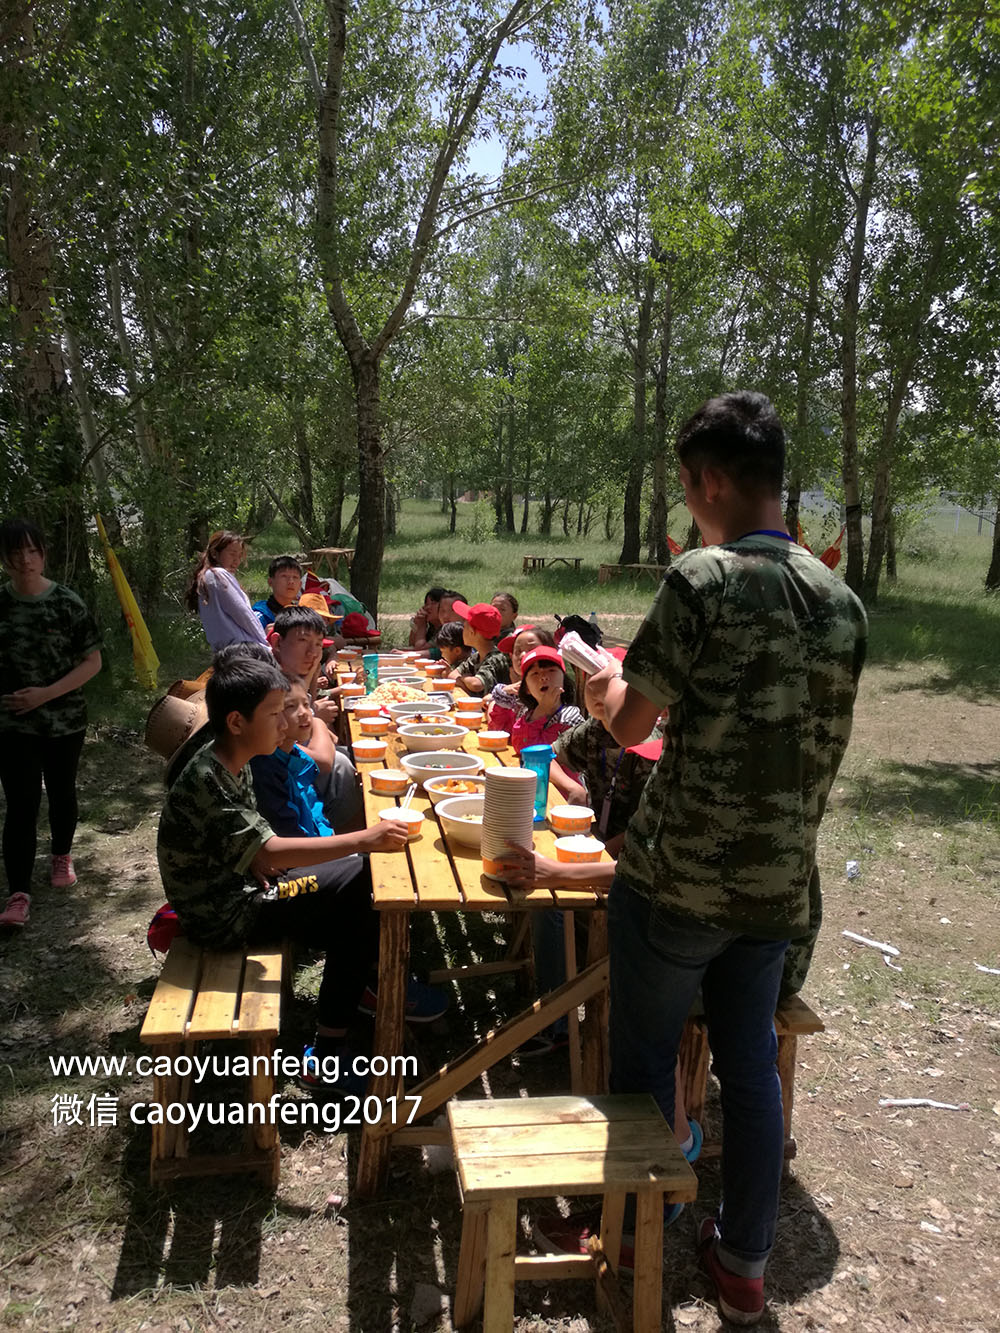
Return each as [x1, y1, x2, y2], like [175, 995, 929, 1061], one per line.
[0, 668, 1000, 1333]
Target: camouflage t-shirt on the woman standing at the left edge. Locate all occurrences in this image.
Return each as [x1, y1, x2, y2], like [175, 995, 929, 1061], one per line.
[0, 583, 101, 736]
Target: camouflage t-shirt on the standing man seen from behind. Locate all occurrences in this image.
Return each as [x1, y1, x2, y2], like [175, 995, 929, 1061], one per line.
[619, 533, 868, 938]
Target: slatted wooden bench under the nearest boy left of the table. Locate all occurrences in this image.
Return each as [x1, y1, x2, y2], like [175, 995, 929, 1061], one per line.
[140, 936, 291, 1189]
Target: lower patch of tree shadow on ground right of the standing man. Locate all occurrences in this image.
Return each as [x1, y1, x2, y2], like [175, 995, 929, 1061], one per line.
[837, 760, 1000, 822]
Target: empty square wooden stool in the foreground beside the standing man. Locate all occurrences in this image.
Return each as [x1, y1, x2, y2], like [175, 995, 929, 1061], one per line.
[448, 1094, 697, 1333]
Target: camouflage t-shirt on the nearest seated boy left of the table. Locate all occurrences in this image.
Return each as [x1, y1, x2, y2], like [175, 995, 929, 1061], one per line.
[156, 741, 273, 949]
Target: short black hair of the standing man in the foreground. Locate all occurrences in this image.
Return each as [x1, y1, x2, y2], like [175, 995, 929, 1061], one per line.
[675, 389, 785, 496]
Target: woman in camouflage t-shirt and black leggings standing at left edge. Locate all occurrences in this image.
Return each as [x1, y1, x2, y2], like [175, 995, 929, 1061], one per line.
[0, 519, 101, 926]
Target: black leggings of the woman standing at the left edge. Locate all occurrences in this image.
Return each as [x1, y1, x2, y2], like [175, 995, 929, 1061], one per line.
[0, 732, 84, 893]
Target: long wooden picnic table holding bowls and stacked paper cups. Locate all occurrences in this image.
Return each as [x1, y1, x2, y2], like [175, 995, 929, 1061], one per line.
[349, 714, 608, 1197]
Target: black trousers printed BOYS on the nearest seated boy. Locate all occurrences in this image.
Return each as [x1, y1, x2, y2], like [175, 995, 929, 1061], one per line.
[248, 856, 379, 1028]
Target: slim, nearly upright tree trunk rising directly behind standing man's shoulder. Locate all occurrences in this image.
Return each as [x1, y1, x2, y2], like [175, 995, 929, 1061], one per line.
[840, 117, 881, 593]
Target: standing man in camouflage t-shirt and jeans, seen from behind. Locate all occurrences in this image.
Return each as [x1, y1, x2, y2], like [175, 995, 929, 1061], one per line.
[587, 393, 867, 1324]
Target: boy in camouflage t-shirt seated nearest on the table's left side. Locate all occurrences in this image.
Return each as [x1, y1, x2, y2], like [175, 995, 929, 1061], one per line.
[156, 653, 407, 1096]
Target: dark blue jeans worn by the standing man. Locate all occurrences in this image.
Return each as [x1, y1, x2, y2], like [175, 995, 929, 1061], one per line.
[608, 876, 788, 1277]
